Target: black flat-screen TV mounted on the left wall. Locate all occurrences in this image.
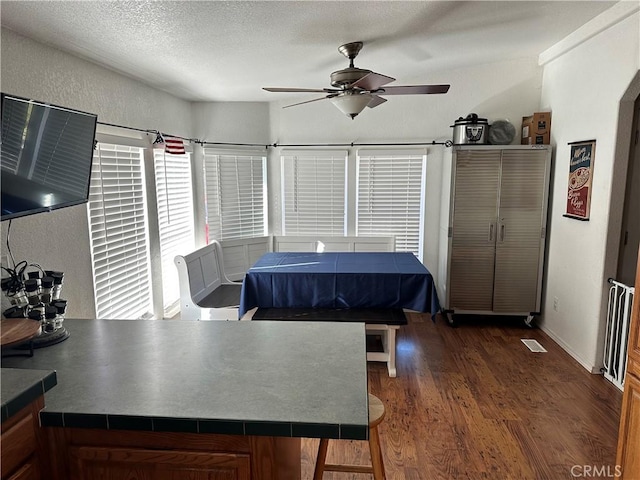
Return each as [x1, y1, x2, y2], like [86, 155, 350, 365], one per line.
[0, 93, 97, 220]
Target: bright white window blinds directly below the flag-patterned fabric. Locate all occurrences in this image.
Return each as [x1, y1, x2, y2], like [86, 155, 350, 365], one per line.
[153, 150, 195, 311]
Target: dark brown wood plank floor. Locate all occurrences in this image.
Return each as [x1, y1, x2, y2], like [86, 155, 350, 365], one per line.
[302, 314, 622, 480]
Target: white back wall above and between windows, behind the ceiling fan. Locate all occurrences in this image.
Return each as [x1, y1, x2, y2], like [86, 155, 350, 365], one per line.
[269, 58, 542, 281]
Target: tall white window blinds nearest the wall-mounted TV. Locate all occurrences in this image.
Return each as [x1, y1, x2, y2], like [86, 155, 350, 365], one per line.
[88, 143, 152, 319]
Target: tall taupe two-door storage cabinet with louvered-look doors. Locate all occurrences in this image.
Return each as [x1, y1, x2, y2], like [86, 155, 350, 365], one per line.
[444, 145, 551, 323]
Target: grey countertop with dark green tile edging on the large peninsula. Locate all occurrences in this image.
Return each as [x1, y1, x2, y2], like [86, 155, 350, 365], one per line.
[2, 319, 368, 439]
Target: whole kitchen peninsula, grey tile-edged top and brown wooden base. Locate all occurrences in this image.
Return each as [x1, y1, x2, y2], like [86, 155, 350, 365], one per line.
[3, 320, 368, 480]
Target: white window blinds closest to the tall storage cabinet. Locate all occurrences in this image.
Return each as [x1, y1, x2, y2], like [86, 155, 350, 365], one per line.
[356, 150, 427, 259]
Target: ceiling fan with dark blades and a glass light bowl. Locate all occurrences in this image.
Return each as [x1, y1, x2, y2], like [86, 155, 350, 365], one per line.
[263, 42, 449, 119]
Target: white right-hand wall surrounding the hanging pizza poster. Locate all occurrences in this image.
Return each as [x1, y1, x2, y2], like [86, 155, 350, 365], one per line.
[541, 12, 640, 371]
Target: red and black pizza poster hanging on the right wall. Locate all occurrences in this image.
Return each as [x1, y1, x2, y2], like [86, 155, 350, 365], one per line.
[564, 140, 596, 220]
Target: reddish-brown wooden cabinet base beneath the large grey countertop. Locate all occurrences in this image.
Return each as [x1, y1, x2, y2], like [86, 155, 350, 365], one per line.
[46, 428, 300, 480]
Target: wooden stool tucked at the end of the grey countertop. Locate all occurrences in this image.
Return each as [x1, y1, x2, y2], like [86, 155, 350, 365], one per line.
[313, 394, 386, 480]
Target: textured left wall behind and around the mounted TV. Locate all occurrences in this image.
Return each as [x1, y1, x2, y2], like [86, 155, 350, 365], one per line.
[0, 29, 192, 318]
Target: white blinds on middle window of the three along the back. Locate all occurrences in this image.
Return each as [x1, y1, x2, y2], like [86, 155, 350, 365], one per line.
[281, 150, 347, 235]
